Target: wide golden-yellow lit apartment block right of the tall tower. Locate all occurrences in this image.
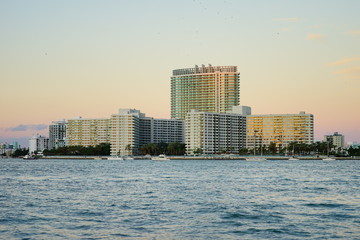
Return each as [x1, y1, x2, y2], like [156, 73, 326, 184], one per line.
[246, 112, 314, 149]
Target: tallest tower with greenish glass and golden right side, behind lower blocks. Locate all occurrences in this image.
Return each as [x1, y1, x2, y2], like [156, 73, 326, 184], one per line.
[171, 65, 240, 119]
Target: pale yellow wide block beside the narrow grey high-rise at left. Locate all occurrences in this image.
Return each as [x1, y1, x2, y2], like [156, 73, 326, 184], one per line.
[66, 117, 110, 147]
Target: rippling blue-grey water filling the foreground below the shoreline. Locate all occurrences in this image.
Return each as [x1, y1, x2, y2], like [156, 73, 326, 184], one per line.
[0, 159, 360, 240]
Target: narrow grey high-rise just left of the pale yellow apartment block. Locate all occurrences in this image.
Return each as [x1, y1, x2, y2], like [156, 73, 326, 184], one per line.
[49, 120, 66, 149]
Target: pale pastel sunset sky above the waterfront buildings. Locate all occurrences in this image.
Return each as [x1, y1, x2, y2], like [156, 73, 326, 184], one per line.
[0, 0, 360, 145]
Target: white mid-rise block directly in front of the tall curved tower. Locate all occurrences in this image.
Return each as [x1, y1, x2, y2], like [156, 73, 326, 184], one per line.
[185, 106, 246, 155]
